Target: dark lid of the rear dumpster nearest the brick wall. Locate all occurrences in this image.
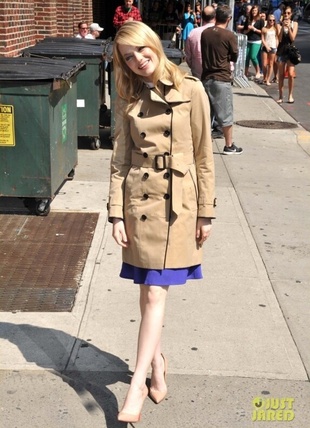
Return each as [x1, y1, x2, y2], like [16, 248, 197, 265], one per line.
[23, 39, 104, 59]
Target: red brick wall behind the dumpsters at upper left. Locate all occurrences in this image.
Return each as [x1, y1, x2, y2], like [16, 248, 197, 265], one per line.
[0, 0, 93, 56]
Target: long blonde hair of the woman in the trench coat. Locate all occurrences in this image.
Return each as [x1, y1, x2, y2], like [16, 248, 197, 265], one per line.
[113, 21, 186, 103]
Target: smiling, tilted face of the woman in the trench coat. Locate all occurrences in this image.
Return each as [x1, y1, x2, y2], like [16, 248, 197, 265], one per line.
[119, 45, 159, 82]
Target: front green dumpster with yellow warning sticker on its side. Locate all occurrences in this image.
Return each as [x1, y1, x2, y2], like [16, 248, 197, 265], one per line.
[0, 58, 85, 215]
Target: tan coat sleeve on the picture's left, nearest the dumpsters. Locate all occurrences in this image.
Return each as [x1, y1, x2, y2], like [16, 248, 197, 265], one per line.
[108, 98, 133, 222]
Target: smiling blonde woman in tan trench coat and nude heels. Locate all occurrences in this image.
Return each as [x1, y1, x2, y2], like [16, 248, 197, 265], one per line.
[108, 22, 214, 423]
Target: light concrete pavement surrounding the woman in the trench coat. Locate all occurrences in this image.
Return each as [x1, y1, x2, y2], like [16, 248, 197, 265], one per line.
[0, 79, 310, 428]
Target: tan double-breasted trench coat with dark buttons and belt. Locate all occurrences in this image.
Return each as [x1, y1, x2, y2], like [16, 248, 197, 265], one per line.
[108, 76, 215, 269]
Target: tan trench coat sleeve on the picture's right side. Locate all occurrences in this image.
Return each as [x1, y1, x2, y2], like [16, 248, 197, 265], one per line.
[191, 80, 215, 218]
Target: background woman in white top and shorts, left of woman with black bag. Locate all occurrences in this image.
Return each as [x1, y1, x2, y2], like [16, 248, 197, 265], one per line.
[262, 15, 279, 86]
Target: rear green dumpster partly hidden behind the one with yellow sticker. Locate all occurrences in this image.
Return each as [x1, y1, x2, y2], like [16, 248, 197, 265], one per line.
[23, 37, 105, 149]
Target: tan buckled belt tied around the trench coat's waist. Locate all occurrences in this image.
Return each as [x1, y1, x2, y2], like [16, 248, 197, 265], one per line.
[131, 151, 194, 215]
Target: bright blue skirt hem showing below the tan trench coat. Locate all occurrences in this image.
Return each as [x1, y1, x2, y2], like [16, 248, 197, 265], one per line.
[120, 263, 202, 286]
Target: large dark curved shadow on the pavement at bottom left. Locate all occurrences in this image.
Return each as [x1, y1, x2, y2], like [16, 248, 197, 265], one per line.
[0, 323, 132, 428]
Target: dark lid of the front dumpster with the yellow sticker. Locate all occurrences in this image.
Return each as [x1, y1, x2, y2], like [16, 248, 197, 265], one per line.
[0, 57, 86, 80]
